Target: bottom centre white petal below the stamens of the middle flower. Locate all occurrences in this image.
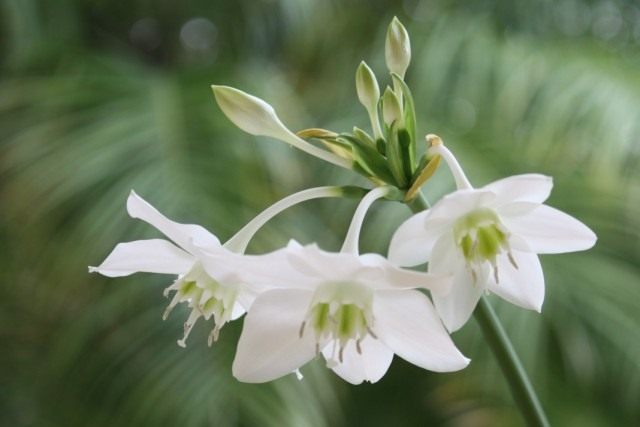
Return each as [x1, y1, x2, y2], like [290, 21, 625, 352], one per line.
[322, 335, 393, 385]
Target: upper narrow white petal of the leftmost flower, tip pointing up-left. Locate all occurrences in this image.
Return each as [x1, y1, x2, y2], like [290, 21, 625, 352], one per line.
[127, 191, 220, 252]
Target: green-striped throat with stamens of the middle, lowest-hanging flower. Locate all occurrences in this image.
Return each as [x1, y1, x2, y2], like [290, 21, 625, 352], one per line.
[300, 282, 377, 364]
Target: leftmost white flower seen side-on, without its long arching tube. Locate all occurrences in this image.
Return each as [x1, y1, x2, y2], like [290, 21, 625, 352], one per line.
[89, 191, 250, 347]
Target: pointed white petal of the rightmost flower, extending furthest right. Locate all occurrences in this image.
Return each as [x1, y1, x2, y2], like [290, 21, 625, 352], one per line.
[503, 205, 597, 254]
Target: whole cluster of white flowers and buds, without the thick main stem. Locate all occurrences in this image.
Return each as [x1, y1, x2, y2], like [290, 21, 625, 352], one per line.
[90, 18, 596, 384]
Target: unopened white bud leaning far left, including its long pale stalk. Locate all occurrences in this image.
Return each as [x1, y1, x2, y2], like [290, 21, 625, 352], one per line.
[211, 85, 351, 169]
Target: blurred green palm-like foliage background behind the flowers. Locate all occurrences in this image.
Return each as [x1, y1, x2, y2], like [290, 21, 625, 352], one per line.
[0, 0, 640, 427]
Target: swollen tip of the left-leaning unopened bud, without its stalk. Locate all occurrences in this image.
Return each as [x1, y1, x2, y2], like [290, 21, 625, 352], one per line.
[211, 85, 291, 140]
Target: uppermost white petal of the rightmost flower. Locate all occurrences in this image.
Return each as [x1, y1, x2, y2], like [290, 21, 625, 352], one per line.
[482, 173, 553, 205]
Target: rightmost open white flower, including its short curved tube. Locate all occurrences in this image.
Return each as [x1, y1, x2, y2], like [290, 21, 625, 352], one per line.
[389, 136, 596, 331]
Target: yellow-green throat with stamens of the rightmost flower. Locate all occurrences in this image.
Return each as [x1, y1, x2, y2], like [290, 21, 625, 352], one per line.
[453, 208, 518, 284]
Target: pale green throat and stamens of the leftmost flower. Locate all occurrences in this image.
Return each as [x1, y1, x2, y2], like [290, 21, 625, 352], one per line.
[162, 263, 238, 347]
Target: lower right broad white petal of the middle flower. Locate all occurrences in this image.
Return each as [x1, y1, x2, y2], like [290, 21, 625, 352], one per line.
[373, 290, 469, 372]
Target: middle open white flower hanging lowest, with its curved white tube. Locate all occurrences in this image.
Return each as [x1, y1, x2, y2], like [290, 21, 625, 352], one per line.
[228, 188, 469, 384]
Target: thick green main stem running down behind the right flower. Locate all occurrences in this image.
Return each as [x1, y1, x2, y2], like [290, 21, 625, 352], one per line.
[408, 193, 549, 427]
